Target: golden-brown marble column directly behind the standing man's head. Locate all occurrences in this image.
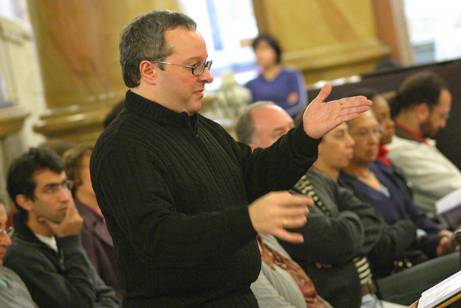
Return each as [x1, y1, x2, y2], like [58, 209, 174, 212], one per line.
[28, 0, 177, 141]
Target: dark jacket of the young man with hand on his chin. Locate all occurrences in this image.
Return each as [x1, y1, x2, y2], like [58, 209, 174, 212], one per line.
[4, 213, 118, 308]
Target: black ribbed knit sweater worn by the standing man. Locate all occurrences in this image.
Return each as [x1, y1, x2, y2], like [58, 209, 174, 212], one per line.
[91, 91, 318, 307]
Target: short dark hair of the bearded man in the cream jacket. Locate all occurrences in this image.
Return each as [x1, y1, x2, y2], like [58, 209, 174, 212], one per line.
[391, 71, 447, 114]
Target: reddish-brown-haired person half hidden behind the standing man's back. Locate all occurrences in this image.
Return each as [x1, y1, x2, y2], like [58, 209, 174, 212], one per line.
[63, 144, 122, 301]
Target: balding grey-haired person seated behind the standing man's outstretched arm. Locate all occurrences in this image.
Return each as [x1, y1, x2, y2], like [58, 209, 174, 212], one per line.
[236, 102, 328, 307]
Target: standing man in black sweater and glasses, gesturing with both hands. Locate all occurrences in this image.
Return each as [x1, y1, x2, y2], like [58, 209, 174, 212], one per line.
[91, 11, 370, 307]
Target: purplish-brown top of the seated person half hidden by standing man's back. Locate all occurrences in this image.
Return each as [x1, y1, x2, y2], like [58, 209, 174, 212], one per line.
[75, 198, 123, 301]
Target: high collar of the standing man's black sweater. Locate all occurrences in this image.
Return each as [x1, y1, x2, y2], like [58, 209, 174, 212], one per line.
[125, 90, 198, 132]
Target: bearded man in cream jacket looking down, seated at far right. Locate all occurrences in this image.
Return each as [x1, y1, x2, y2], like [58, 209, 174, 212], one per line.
[389, 72, 461, 217]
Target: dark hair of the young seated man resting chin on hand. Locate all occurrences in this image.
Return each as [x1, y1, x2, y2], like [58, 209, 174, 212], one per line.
[7, 148, 64, 211]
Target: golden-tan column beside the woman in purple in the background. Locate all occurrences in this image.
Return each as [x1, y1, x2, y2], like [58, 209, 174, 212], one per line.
[253, 0, 389, 83]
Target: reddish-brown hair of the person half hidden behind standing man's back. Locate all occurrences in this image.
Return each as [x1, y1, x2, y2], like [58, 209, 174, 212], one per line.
[62, 143, 94, 193]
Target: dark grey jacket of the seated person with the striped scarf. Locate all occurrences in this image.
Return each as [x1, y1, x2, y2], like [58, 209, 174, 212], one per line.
[280, 169, 383, 307]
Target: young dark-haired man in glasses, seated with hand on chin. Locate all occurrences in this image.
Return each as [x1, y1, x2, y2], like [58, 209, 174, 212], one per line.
[5, 148, 118, 307]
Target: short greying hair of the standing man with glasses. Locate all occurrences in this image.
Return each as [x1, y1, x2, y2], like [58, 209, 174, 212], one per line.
[119, 11, 197, 88]
